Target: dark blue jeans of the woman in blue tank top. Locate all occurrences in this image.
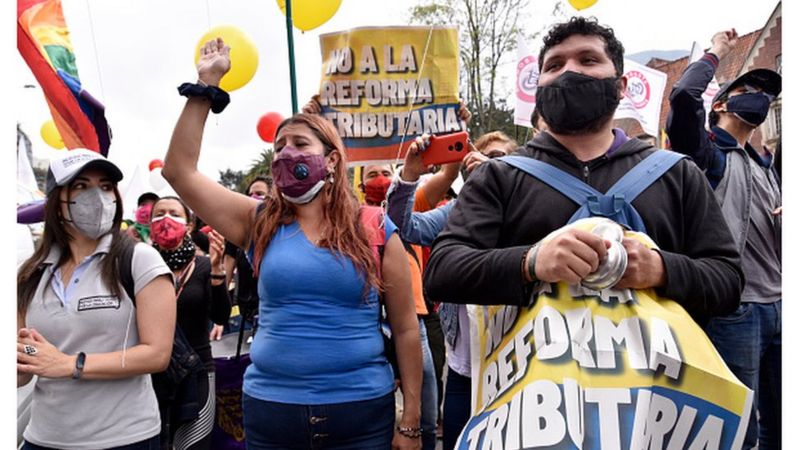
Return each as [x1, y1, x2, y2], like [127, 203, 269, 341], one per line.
[242, 392, 394, 450]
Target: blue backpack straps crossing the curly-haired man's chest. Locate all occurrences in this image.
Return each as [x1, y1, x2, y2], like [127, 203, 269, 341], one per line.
[497, 150, 686, 233]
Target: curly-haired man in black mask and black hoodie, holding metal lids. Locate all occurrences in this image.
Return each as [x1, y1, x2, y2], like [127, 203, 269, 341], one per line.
[425, 17, 743, 324]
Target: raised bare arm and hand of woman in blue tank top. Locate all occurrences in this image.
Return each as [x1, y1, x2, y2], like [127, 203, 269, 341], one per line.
[161, 39, 258, 247]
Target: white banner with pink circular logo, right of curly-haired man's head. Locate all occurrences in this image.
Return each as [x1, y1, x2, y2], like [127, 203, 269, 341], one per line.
[614, 59, 667, 137]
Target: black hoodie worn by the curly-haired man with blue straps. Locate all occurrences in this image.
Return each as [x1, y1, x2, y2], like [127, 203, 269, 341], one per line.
[425, 133, 744, 323]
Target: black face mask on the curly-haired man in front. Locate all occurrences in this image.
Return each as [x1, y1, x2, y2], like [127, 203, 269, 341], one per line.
[536, 71, 619, 135]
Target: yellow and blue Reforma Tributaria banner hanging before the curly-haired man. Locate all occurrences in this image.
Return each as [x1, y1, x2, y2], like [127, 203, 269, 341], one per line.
[456, 219, 752, 450]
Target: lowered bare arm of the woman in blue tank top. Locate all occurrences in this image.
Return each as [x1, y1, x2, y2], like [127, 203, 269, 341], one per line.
[382, 234, 422, 439]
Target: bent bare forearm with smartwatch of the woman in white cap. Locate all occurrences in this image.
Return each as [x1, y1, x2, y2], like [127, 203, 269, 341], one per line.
[17, 275, 176, 380]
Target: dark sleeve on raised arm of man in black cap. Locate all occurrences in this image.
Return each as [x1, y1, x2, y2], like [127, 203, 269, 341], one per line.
[666, 54, 716, 170]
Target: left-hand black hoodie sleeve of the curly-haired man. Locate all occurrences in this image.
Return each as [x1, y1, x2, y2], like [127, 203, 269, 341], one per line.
[424, 164, 530, 305]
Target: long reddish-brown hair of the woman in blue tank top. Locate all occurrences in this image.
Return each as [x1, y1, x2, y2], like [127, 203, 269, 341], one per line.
[250, 113, 382, 294]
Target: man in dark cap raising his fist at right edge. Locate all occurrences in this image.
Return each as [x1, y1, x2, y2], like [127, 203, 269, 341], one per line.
[667, 30, 782, 449]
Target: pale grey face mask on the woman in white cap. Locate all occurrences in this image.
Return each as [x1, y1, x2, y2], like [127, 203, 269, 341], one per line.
[67, 187, 117, 239]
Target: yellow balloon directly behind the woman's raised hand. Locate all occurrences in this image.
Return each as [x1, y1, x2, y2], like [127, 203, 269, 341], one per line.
[194, 25, 258, 92]
